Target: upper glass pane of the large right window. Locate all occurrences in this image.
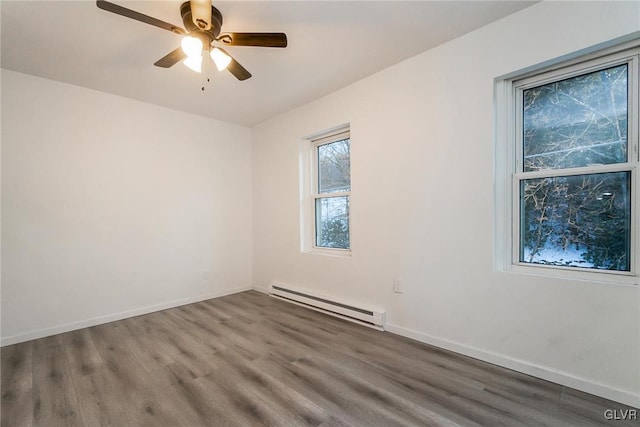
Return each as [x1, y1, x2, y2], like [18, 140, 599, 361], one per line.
[523, 64, 627, 172]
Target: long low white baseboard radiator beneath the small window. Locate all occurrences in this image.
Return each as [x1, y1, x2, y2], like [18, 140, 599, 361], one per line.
[269, 284, 386, 331]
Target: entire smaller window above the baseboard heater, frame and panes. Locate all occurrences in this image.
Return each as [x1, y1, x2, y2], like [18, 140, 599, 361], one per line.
[303, 129, 351, 254]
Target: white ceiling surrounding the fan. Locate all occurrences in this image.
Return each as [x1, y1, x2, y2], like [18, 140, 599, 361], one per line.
[0, 0, 535, 126]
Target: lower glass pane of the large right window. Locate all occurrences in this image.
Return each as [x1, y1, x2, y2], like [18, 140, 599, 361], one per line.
[520, 172, 631, 271]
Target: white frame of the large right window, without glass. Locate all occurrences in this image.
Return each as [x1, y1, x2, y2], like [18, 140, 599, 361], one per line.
[494, 41, 640, 284]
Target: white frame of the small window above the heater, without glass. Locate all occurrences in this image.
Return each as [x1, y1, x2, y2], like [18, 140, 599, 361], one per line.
[300, 125, 353, 256]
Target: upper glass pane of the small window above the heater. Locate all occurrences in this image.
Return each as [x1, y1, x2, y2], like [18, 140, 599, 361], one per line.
[318, 138, 351, 193]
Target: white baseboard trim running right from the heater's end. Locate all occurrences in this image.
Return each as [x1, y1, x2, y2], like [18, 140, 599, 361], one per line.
[385, 323, 640, 408]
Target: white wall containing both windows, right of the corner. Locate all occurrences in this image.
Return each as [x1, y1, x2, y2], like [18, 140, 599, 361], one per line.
[253, 2, 640, 406]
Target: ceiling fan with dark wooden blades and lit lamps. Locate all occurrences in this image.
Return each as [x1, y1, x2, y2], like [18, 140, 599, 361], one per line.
[96, 0, 287, 82]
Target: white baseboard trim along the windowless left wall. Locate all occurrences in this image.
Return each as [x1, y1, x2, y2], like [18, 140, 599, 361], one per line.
[0, 286, 252, 347]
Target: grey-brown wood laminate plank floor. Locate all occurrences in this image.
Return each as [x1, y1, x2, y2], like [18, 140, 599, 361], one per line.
[2, 291, 640, 427]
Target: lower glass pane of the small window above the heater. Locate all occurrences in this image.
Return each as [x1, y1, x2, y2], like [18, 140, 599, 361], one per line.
[316, 196, 349, 249]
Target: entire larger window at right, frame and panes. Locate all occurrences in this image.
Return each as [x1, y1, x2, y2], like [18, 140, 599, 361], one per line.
[499, 43, 639, 275]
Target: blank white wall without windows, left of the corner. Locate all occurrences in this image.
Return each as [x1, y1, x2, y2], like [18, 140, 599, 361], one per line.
[2, 70, 252, 344]
